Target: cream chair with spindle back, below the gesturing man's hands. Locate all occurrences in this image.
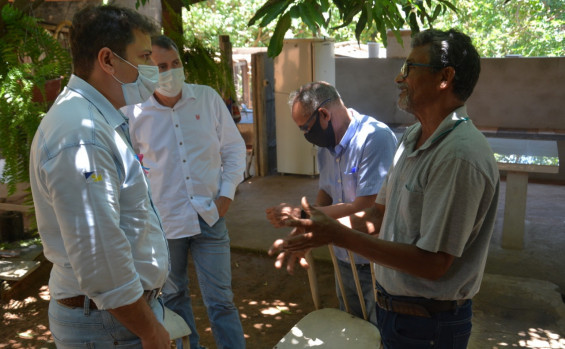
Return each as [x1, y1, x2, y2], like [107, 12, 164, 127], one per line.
[274, 246, 381, 349]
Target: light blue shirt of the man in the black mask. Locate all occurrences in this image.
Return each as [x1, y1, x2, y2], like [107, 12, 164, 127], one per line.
[318, 109, 396, 264]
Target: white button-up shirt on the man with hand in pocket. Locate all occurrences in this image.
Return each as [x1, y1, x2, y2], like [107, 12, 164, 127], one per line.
[123, 83, 245, 239]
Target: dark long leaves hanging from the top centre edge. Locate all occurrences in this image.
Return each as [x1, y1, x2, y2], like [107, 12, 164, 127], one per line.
[248, 0, 456, 57]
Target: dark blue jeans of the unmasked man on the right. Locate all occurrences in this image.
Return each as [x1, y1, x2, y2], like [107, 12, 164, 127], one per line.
[377, 284, 473, 349]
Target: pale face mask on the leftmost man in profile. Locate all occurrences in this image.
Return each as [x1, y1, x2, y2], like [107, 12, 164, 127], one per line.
[112, 53, 159, 105]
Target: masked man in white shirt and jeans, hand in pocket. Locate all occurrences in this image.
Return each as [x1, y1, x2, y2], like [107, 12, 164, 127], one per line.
[124, 36, 245, 349]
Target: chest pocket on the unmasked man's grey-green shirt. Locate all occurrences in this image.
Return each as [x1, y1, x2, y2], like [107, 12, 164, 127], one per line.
[395, 184, 424, 243]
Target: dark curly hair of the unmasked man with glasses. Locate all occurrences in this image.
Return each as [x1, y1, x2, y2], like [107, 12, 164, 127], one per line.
[412, 29, 481, 101]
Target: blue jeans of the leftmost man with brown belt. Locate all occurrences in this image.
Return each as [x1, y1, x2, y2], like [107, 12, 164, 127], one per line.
[49, 299, 164, 349]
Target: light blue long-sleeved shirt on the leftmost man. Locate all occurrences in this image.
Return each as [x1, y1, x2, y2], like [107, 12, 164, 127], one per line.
[30, 75, 169, 309]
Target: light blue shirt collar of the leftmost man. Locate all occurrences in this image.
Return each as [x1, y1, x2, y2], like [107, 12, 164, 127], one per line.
[67, 74, 128, 128]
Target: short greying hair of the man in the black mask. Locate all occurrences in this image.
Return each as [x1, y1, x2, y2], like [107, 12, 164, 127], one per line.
[288, 81, 341, 113]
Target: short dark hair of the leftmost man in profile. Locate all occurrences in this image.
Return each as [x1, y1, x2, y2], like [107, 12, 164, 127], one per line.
[70, 5, 158, 79]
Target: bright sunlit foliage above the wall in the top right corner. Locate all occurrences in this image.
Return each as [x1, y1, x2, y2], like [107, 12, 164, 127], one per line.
[430, 0, 565, 57]
